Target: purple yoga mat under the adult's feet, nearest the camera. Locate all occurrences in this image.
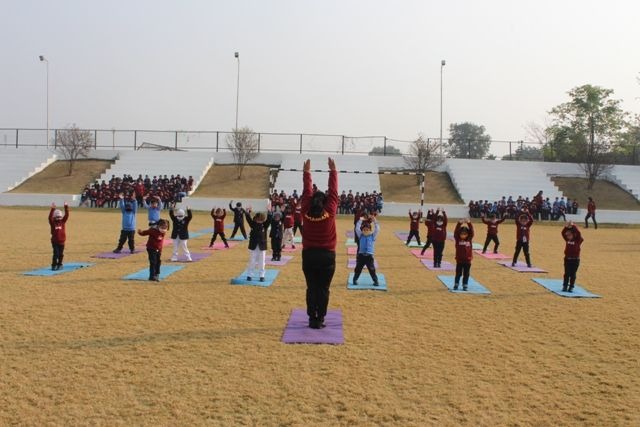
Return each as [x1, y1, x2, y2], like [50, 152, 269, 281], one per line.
[282, 308, 344, 344]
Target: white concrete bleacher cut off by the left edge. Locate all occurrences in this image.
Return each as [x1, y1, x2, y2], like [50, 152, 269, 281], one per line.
[0, 147, 57, 192]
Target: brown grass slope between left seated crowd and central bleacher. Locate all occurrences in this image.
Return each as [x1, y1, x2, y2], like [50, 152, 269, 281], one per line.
[191, 165, 270, 199]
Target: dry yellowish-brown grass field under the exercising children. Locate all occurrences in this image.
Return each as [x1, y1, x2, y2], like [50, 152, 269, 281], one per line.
[0, 208, 640, 426]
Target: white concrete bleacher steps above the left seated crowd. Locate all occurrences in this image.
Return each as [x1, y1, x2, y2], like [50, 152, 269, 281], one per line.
[98, 150, 213, 192]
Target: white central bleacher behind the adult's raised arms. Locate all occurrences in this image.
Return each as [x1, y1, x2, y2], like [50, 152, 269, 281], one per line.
[274, 155, 380, 194]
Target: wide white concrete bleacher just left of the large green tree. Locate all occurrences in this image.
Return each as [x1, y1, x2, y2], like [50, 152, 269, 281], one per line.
[445, 159, 563, 203]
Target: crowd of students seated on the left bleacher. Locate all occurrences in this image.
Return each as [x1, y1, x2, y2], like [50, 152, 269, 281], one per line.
[80, 174, 193, 209]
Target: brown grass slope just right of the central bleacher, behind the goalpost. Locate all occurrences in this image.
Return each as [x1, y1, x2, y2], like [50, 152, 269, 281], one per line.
[380, 171, 464, 204]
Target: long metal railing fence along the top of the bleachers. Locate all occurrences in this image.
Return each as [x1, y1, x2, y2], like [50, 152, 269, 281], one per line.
[0, 128, 640, 165]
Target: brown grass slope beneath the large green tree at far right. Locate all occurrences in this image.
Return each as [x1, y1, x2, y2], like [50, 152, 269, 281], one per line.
[552, 177, 640, 211]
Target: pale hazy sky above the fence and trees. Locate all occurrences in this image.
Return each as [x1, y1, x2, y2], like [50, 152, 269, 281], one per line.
[0, 0, 640, 157]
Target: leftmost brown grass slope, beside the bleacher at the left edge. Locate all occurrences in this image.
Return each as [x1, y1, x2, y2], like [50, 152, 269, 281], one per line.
[10, 160, 113, 194]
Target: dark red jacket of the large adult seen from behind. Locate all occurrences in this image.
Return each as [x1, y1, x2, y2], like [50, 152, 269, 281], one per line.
[300, 171, 338, 252]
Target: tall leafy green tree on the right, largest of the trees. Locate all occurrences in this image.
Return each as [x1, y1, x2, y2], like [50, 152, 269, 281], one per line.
[550, 85, 625, 189]
